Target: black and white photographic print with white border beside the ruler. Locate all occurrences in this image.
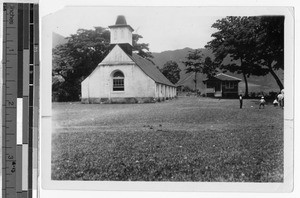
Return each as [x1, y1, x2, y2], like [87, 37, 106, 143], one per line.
[42, 6, 293, 193]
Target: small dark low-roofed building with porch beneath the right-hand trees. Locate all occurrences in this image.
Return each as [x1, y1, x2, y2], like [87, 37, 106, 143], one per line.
[203, 73, 242, 98]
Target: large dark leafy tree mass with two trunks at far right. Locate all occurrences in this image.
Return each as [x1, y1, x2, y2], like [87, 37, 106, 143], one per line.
[207, 17, 283, 96]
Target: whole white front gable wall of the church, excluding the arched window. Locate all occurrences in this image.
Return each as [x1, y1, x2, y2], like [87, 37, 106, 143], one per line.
[82, 45, 163, 103]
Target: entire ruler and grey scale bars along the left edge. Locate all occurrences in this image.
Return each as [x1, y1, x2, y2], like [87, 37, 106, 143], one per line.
[2, 3, 39, 198]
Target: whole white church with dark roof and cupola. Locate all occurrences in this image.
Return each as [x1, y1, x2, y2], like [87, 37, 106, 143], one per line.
[81, 16, 176, 104]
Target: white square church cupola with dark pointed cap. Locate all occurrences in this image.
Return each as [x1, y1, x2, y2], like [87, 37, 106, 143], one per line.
[108, 15, 134, 55]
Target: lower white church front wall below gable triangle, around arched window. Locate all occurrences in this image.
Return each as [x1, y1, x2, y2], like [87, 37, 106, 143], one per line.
[82, 65, 156, 103]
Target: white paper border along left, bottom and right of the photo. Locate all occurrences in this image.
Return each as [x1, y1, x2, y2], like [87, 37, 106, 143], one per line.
[41, 1, 294, 195]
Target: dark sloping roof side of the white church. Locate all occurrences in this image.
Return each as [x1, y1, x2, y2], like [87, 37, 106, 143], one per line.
[129, 53, 175, 87]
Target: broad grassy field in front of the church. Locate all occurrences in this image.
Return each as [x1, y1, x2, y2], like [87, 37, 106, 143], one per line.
[52, 97, 283, 182]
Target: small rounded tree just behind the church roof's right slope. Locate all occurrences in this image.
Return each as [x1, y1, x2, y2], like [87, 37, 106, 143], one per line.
[160, 61, 181, 84]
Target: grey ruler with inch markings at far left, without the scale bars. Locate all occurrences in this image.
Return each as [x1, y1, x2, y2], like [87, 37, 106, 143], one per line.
[2, 3, 18, 198]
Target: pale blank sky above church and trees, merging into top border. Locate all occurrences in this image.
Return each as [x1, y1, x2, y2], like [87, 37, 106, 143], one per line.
[44, 6, 292, 52]
